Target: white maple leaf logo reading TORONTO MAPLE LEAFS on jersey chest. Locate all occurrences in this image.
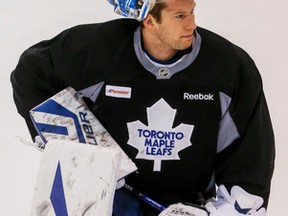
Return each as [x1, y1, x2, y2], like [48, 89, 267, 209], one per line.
[127, 98, 194, 171]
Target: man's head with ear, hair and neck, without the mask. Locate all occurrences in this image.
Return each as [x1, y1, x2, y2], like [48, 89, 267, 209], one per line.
[142, 0, 196, 60]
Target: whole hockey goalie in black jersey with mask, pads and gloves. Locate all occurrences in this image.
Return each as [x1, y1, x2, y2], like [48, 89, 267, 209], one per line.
[11, 0, 275, 216]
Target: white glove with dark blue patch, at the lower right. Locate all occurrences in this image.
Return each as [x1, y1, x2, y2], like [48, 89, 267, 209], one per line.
[205, 185, 266, 216]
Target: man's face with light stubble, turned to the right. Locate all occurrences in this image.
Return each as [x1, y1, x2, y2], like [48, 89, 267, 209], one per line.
[154, 0, 196, 50]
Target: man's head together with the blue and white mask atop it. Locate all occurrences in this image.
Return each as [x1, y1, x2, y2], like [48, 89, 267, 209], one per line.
[108, 0, 196, 60]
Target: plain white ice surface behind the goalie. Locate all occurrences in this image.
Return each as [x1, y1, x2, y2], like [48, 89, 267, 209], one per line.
[0, 0, 288, 216]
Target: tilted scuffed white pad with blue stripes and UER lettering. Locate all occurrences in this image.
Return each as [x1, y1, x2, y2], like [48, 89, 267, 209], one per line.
[30, 87, 137, 179]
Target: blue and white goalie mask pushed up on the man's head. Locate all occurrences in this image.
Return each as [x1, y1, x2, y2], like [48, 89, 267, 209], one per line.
[107, 0, 156, 21]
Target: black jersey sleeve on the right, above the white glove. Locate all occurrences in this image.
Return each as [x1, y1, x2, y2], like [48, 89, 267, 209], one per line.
[215, 48, 275, 207]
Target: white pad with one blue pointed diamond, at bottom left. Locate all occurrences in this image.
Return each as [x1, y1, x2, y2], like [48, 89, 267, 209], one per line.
[30, 140, 121, 216]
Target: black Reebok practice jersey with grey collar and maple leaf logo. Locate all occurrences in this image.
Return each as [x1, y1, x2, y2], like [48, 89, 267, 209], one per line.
[11, 19, 274, 209]
